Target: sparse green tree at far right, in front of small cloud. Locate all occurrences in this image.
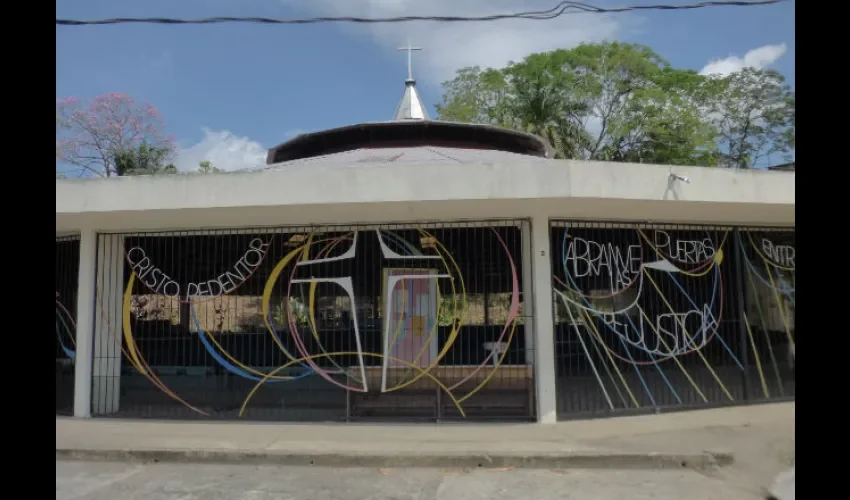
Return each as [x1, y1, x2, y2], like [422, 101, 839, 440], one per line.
[709, 68, 796, 168]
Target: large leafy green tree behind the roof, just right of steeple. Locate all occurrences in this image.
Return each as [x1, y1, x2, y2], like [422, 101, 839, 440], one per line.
[437, 42, 740, 165]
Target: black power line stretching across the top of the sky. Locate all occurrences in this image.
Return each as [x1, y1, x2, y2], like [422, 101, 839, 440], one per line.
[56, 0, 786, 26]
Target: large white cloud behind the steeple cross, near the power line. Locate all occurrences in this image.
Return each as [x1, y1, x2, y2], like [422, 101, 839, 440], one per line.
[280, 0, 625, 85]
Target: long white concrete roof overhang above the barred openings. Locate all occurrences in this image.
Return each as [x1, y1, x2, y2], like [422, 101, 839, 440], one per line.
[56, 159, 795, 231]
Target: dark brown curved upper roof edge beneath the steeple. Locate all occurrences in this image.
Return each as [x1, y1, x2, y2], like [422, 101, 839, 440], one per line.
[266, 120, 554, 165]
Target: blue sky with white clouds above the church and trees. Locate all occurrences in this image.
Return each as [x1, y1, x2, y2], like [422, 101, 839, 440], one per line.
[56, 0, 795, 169]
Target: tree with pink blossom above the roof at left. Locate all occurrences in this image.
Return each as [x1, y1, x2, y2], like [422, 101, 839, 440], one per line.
[56, 93, 174, 177]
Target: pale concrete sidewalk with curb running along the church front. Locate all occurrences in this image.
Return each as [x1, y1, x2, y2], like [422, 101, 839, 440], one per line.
[56, 403, 794, 477]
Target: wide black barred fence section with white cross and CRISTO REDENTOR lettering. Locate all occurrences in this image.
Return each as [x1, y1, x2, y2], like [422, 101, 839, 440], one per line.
[92, 220, 536, 421]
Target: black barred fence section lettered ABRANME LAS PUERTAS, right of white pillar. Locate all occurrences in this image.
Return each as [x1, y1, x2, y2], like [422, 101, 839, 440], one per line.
[550, 221, 795, 418]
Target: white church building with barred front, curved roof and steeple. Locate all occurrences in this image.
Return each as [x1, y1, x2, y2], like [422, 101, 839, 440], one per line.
[56, 47, 796, 423]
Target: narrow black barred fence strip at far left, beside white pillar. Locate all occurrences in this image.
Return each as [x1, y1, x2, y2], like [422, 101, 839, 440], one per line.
[54, 235, 80, 415]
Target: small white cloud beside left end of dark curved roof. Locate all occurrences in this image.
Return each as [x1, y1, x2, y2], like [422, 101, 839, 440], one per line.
[174, 127, 266, 172]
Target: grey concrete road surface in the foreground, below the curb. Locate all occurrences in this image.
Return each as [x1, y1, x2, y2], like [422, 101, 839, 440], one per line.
[56, 461, 764, 500]
